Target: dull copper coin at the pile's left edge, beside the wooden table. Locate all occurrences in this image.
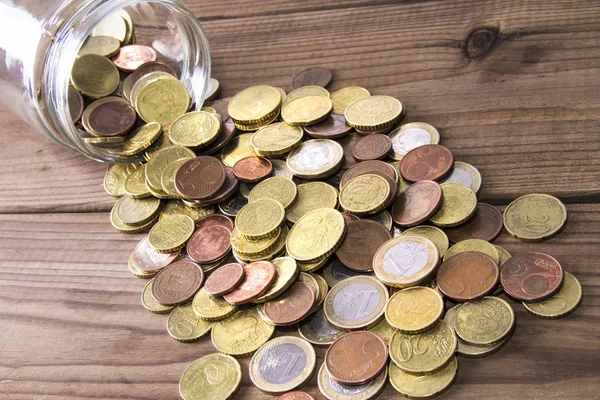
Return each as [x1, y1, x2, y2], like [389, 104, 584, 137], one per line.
[152, 260, 204, 306]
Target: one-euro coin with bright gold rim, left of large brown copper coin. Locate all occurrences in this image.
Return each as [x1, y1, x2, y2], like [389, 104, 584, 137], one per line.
[373, 235, 440, 288]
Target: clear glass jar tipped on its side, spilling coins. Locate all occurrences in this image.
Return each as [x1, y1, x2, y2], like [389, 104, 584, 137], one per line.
[0, 0, 210, 162]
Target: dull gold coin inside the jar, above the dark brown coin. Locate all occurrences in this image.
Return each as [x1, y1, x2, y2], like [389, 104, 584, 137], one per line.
[71, 54, 119, 99]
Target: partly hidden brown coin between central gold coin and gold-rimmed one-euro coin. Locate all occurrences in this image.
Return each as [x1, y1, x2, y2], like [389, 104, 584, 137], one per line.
[335, 219, 392, 272]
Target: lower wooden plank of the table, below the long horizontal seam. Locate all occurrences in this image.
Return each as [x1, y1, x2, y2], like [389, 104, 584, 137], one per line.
[0, 204, 600, 400]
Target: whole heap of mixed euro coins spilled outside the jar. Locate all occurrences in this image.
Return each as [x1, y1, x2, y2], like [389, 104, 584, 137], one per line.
[92, 59, 581, 399]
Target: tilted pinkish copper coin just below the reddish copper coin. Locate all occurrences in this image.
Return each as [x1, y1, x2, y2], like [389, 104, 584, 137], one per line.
[392, 181, 442, 227]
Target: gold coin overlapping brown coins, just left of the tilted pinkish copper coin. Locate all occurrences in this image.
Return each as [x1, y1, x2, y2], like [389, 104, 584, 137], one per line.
[340, 174, 391, 216]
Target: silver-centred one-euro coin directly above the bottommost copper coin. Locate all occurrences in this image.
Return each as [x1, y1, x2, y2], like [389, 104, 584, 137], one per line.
[323, 276, 389, 329]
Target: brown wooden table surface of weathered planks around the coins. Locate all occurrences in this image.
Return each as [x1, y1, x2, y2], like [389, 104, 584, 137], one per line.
[0, 0, 600, 400]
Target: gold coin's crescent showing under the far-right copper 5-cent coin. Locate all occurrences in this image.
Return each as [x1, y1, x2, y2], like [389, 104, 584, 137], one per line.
[523, 272, 582, 319]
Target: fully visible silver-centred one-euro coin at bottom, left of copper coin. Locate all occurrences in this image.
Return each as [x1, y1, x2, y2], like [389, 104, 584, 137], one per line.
[249, 336, 317, 393]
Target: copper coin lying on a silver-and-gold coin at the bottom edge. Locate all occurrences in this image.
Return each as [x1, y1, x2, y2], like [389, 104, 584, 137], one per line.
[325, 331, 388, 385]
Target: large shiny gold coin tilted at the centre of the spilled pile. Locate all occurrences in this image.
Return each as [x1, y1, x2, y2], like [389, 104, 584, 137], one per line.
[288, 203, 346, 262]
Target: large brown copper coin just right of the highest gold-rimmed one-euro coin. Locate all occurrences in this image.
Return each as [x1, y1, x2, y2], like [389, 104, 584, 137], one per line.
[436, 251, 500, 301]
